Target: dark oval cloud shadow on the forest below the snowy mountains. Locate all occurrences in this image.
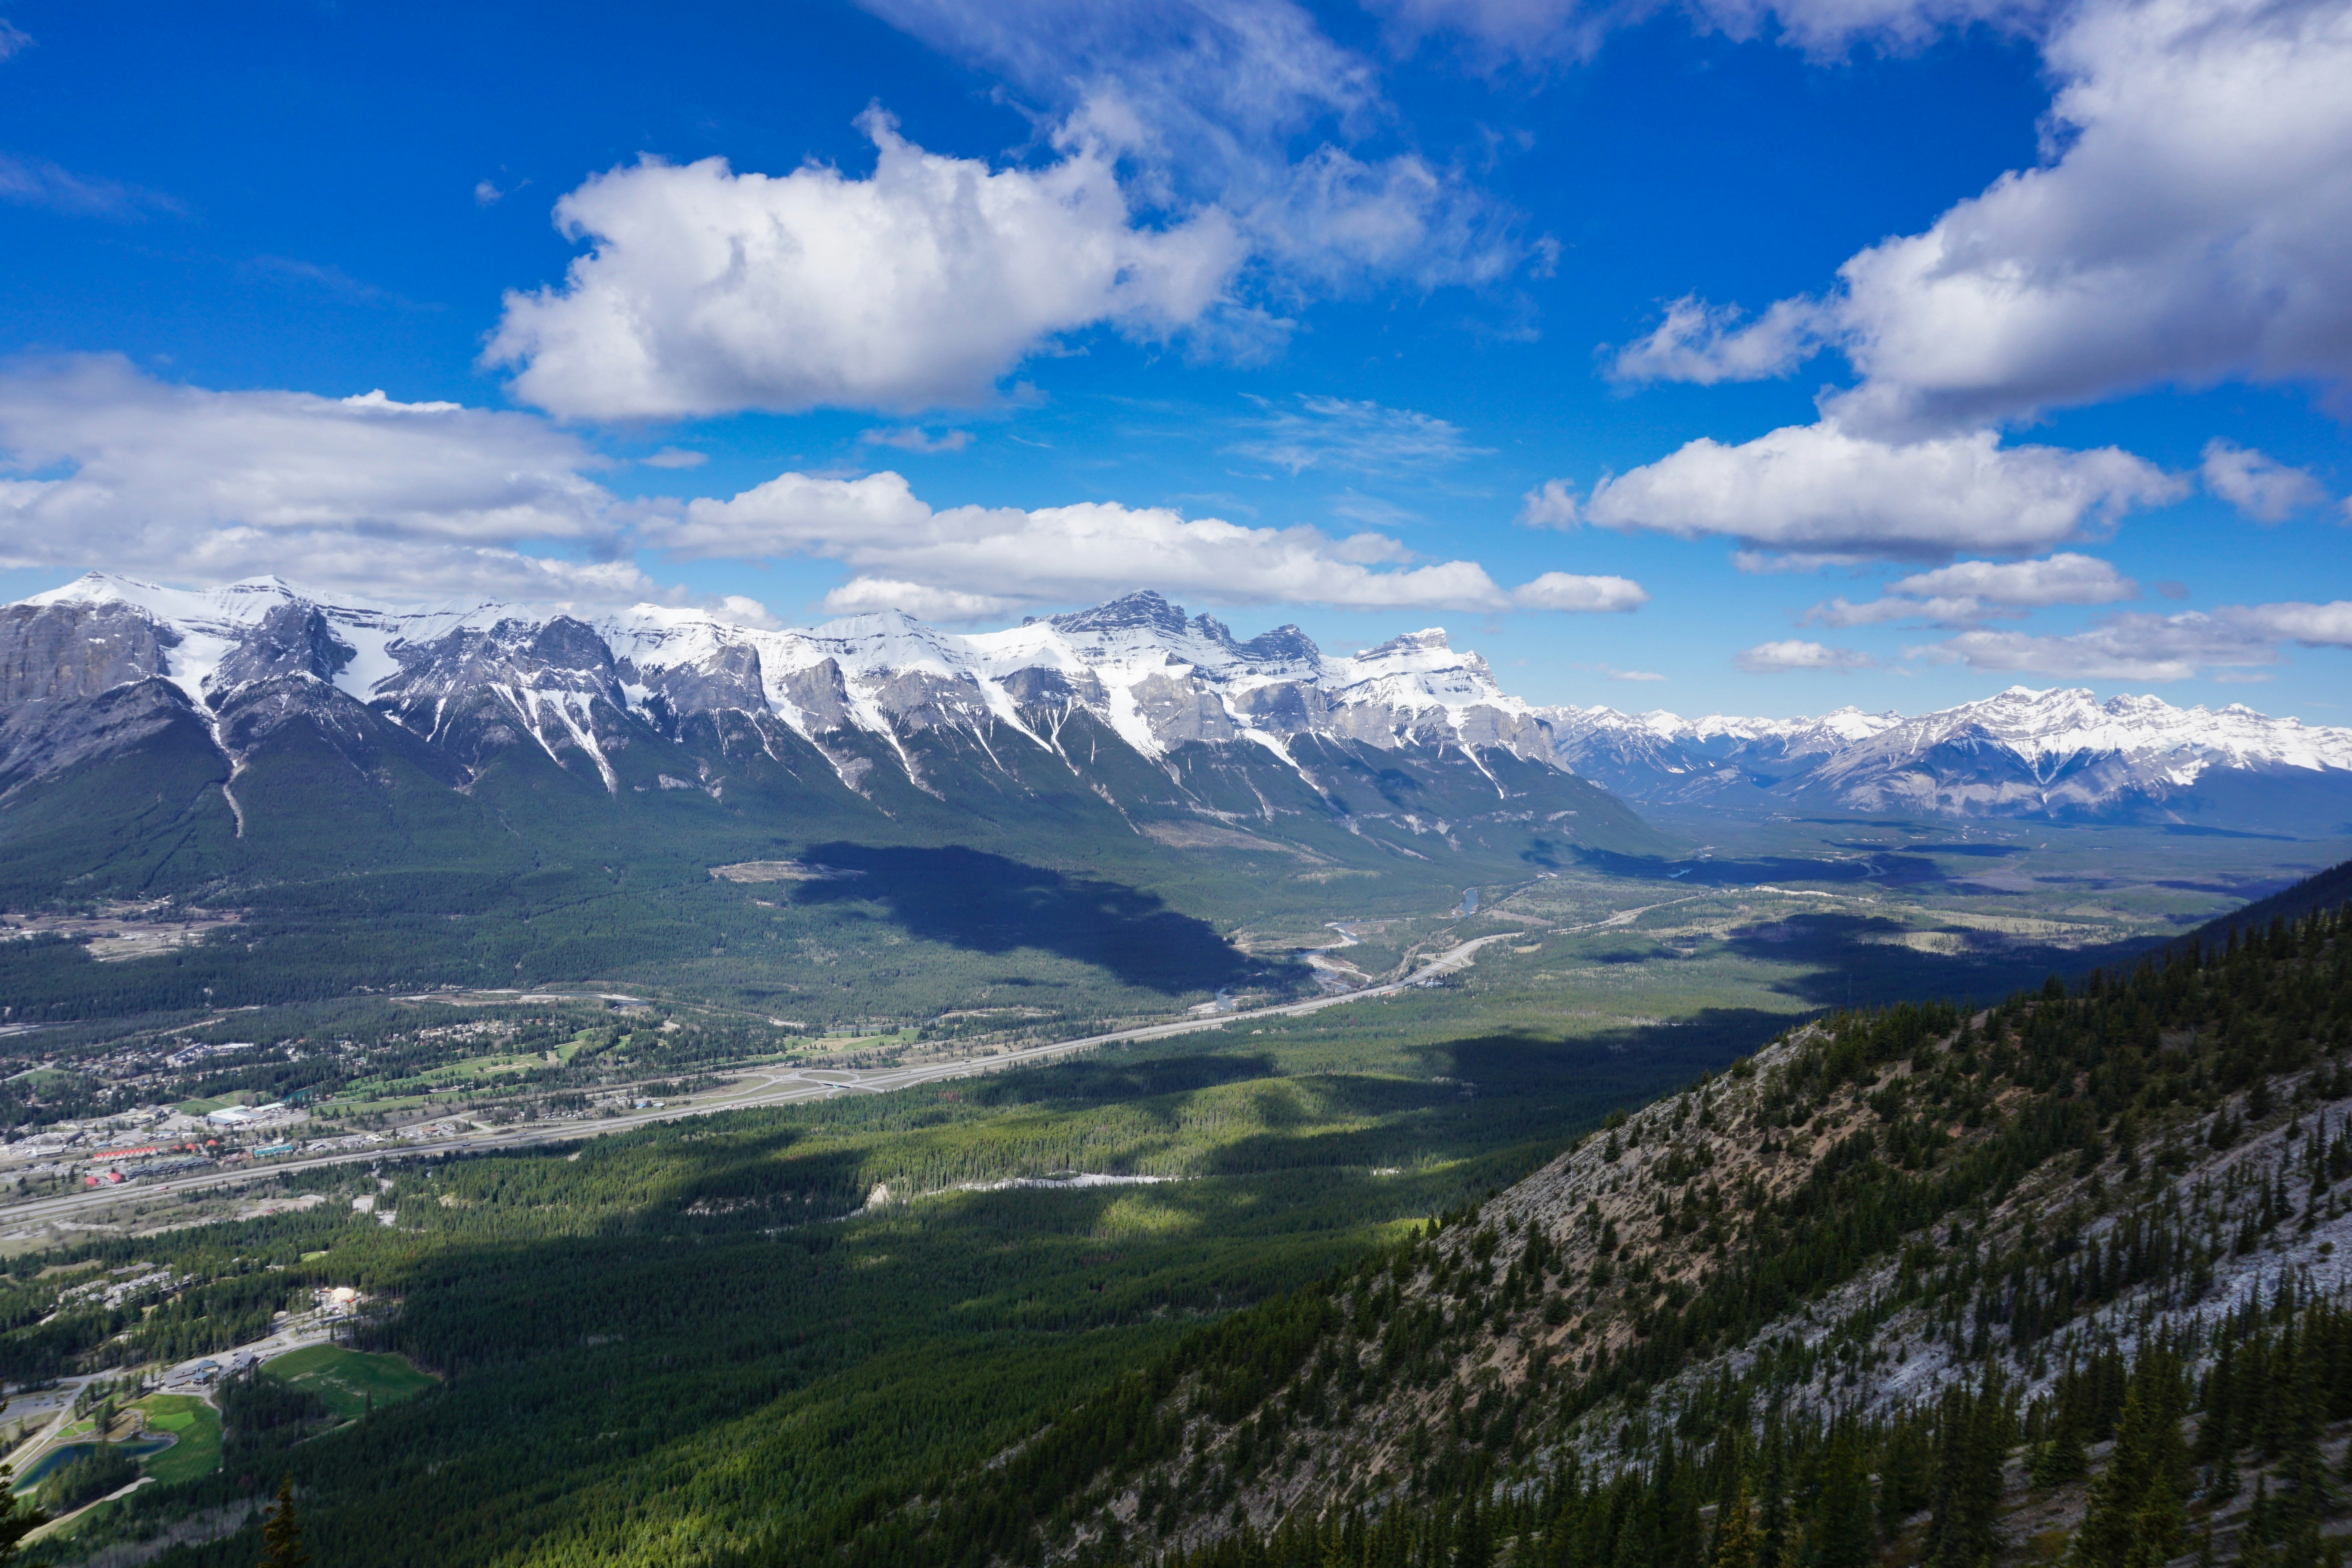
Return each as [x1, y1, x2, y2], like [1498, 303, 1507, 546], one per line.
[795, 844, 1261, 995]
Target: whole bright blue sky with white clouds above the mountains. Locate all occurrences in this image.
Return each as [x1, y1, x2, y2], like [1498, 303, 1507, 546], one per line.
[0, 0, 2352, 722]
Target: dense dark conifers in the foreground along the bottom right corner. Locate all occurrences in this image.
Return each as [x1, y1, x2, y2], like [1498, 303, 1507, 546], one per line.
[1148, 1288, 2352, 1568]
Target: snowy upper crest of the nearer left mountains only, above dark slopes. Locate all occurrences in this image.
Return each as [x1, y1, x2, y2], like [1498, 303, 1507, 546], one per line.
[0, 573, 1550, 783]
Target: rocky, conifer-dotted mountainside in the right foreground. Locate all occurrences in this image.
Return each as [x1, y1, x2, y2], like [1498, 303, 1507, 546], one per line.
[929, 872, 2352, 1568]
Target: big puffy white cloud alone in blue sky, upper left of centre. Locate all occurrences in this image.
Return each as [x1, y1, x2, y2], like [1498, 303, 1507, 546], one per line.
[485, 111, 1242, 418]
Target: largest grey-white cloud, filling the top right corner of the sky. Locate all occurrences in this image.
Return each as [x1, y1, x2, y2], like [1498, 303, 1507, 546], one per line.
[1618, 0, 2352, 432]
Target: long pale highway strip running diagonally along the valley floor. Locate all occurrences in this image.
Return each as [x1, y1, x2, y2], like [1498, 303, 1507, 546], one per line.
[0, 898, 1618, 1227]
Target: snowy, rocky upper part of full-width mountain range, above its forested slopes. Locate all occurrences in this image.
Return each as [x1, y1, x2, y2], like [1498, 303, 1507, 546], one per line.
[14, 573, 2352, 832]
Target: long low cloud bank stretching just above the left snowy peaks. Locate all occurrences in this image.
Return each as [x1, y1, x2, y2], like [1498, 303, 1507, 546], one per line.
[0, 358, 1649, 623]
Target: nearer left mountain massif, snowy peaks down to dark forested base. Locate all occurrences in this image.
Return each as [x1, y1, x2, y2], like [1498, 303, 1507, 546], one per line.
[0, 576, 1668, 896]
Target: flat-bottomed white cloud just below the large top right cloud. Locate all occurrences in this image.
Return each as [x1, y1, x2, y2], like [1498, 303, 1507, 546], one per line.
[1585, 418, 2183, 559]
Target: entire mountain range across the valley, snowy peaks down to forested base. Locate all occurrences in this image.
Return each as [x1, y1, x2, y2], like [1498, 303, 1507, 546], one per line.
[0, 573, 2352, 912]
